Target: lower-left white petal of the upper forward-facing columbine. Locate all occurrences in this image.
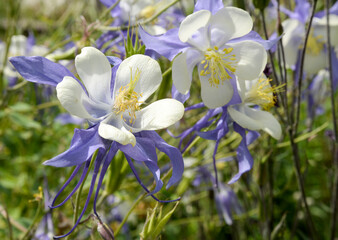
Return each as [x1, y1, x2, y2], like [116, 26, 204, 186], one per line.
[172, 49, 202, 94]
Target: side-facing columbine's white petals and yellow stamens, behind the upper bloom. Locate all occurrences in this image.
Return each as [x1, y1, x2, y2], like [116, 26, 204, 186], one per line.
[228, 74, 282, 139]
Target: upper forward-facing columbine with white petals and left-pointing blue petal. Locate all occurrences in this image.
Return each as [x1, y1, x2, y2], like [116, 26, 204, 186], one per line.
[140, 1, 267, 108]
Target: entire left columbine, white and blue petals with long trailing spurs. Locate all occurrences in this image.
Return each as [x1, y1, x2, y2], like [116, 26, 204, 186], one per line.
[11, 47, 184, 238]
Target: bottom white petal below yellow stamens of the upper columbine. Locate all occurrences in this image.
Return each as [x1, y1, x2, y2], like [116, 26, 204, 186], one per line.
[198, 64, 234, 108]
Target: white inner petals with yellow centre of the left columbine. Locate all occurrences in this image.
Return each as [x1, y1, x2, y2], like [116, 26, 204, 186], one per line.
[56, 47, 184, 146]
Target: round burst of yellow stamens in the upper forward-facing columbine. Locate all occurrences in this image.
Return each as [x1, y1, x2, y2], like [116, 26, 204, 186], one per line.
[200, 46, 237, 88]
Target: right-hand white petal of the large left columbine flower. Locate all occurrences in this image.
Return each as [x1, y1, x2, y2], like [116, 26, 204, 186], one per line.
[124, 99, 184, 132]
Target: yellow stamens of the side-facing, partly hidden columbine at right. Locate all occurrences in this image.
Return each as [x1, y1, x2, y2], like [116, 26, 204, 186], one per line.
[245, 78, 284, 111]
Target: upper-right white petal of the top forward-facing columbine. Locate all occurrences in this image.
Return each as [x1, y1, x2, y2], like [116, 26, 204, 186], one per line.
[210, 7, 253, 39]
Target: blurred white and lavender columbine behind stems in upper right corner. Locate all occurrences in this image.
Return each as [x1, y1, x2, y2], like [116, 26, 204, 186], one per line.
[281, 0, 338, 76]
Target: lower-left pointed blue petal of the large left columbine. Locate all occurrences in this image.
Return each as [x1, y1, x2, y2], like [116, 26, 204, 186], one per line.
[44, 125, 106, 167]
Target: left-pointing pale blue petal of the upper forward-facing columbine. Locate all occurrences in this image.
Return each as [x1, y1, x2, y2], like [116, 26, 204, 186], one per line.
[139, 27, 189, 61]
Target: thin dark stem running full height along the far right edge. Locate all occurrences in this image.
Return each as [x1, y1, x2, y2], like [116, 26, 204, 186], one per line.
[325, 0, 338, 240]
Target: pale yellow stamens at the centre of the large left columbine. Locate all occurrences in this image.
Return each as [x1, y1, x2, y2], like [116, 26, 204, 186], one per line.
[113, 69, 142, 124]
